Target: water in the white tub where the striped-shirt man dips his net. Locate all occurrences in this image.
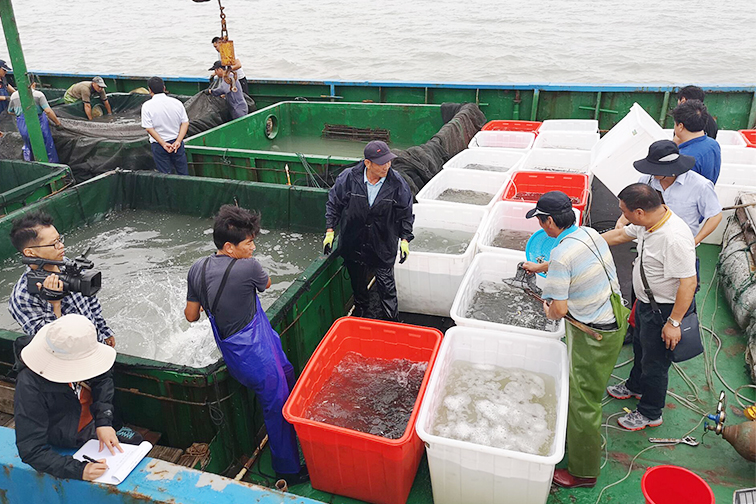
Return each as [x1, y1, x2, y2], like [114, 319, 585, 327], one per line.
[465, 281, 559, 332]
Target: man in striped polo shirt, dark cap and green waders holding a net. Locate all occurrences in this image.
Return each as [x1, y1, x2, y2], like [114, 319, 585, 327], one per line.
[523, 191, 630, 488]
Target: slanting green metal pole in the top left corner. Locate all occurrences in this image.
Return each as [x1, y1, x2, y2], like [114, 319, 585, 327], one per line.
[0, 0, 50, 163]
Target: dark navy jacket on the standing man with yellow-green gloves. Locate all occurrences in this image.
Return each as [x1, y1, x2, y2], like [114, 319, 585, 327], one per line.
[326, 161, 415, 268]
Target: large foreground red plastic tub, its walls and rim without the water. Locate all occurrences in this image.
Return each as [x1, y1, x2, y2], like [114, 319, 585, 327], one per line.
[283, 317, 442, 504]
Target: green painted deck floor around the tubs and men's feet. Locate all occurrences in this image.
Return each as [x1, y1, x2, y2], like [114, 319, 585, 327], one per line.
[248, 245, 756, 504]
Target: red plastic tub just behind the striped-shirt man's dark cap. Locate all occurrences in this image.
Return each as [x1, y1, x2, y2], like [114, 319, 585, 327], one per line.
[501, 171, 590, 222]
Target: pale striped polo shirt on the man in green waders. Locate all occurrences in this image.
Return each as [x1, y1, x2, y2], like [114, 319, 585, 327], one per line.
[543, 227, 620, 324]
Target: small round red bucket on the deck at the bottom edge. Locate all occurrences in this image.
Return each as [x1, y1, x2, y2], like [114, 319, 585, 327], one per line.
[641, 466, 716, 504]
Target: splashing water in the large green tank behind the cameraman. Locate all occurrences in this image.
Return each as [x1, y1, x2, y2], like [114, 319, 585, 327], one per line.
[0, 210, 321, 367]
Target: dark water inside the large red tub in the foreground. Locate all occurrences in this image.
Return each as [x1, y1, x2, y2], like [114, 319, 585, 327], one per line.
[304, 352, 428, 439]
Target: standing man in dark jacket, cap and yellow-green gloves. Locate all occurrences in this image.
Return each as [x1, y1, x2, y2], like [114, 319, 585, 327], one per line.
[323, 141, 415, 320]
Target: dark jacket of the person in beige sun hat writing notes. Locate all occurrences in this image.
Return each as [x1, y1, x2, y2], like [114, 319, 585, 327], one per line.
[13, 336, 114, 479]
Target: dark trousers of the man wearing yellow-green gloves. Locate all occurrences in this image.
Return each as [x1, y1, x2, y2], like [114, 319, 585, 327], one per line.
[344, 261, 399, 320]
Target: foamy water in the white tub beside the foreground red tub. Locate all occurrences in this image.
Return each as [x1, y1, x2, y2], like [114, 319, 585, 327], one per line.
[431, 361, 557, 456]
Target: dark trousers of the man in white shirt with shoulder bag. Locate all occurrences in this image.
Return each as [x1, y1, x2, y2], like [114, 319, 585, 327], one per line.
[625, 300, 674, 420]
